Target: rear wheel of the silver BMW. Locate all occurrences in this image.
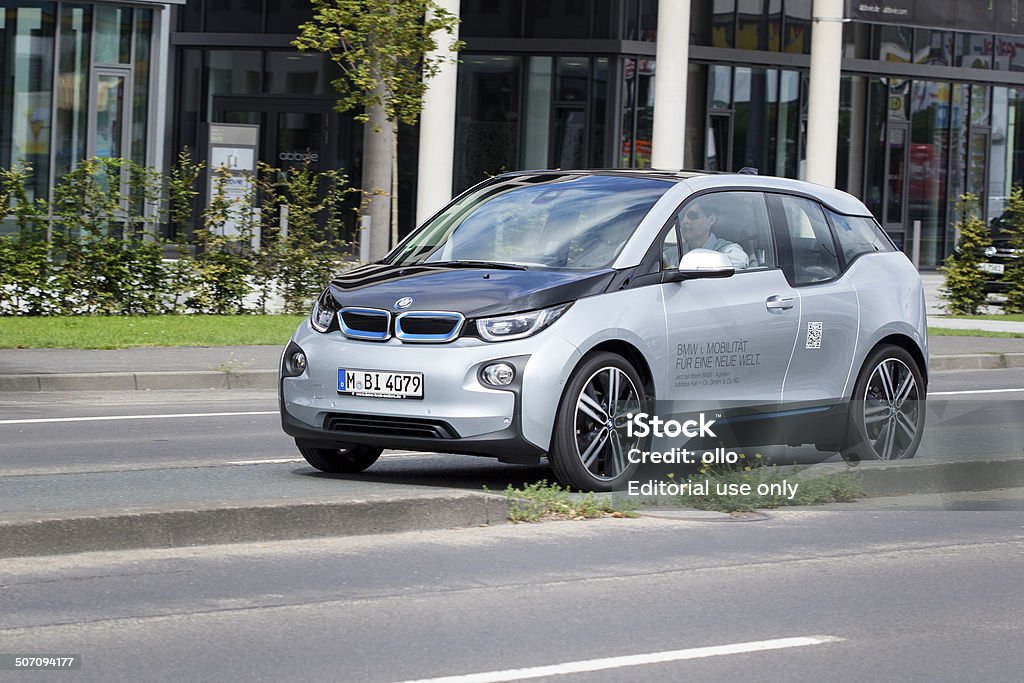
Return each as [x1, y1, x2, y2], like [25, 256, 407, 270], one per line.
[840, 345, 925, 462]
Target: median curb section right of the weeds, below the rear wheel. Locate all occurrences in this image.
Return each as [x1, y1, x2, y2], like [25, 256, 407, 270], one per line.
[800, 457, 1024, 498]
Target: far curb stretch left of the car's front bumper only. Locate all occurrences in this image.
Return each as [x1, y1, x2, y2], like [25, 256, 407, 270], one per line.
[0, 370, 278, 391]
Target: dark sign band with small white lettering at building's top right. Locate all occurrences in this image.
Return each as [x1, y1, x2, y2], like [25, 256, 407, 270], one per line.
[846, 0, 1024, 35]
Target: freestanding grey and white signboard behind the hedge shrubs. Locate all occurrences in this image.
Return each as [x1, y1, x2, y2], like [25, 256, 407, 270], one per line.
[206, 123, 259, 237]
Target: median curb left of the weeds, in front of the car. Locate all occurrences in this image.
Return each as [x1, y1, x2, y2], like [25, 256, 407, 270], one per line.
[0, 492, 508, 558]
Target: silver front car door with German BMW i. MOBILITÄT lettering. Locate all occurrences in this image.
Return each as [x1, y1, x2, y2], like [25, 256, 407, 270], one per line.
[662, 190, 800, 413]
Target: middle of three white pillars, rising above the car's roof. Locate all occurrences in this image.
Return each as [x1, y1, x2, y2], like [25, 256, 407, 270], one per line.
[651, 0, 690, 170]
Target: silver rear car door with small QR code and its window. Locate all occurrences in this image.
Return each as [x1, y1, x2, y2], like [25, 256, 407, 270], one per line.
[768, 195, 859, 410]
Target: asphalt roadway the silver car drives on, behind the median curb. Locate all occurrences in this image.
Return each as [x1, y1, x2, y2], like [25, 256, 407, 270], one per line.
[0, 369, 1024, 479]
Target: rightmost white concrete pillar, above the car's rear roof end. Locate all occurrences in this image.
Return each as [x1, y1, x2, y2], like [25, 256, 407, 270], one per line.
[807, 0, 843, 187]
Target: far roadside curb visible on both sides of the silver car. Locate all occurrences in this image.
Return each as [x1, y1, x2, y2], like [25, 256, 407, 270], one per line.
[0, 353, 1024, 391]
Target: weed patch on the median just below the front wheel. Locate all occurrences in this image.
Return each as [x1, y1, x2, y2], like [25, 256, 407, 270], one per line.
[505, 479, 636, 522]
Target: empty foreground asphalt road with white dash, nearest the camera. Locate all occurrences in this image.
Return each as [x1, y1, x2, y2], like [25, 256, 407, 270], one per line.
[0, 511, 1024, 683]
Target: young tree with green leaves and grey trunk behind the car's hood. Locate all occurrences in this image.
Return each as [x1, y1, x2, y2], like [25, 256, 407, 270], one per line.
[292, 0, 462, 259]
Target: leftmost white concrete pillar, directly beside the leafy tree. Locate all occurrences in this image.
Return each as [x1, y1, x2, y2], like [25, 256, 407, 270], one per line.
[416, 0, 459, 225]
